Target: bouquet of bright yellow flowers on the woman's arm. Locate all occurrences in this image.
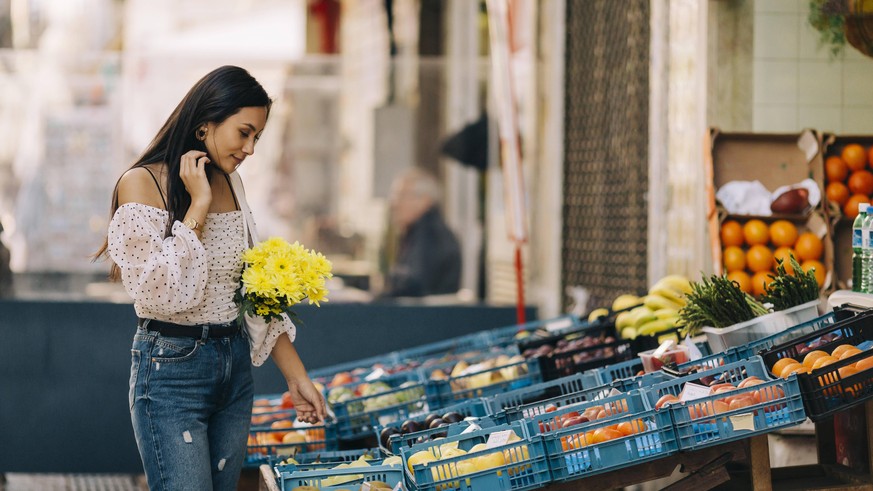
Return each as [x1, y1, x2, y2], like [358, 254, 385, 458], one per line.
[234, 237, 333, 322]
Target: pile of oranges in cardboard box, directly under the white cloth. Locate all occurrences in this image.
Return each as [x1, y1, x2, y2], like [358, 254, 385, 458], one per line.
[721, 219, 824, 296]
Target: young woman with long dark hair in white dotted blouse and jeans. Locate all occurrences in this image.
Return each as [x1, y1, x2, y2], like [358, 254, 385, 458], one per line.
[98, 66, 325, 490]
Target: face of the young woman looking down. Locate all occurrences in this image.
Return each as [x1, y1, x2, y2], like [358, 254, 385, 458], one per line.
[205, 107, 267, 174]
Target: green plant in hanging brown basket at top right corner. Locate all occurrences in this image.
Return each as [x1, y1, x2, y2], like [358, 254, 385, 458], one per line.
[808, 0, 873, 57]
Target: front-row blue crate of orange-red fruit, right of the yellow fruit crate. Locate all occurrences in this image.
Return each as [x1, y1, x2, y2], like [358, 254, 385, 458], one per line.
[525, 390, 679, 481]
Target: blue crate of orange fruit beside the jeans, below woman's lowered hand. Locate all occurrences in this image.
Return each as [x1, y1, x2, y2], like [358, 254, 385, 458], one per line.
[249, 421, 339, 468]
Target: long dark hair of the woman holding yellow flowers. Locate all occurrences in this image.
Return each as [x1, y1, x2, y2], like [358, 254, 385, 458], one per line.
[94, 65, 273, 279]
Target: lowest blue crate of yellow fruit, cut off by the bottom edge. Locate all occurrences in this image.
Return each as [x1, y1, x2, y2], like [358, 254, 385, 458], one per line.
[277, 465, 403, 491]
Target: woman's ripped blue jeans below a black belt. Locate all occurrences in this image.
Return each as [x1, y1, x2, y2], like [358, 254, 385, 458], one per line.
[129, 325, 254, 491]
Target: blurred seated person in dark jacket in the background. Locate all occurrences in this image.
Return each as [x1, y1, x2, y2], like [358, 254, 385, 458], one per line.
[381, 168, 461, 298]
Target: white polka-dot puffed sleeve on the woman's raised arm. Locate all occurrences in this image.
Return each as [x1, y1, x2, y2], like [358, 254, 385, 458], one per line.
[109, 203, 208, 315]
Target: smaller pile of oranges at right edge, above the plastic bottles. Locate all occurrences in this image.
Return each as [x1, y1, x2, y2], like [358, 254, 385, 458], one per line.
[825, 143, 873, 219]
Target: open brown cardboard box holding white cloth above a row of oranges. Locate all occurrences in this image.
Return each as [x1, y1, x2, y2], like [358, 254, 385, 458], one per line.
[705, 128, 833, 290]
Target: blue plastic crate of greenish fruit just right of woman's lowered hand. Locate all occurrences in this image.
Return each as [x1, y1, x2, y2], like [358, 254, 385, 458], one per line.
[328, 372, 428, 440]
